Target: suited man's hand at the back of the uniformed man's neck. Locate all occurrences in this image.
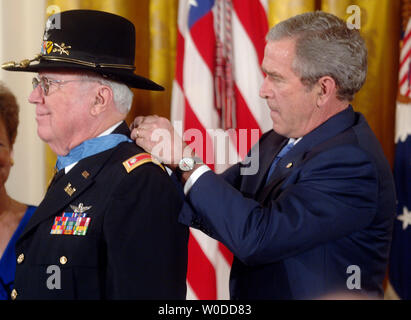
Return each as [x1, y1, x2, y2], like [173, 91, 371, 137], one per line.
[130, 115, 194, 170]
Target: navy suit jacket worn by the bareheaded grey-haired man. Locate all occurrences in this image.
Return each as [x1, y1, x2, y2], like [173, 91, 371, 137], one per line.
[179, 106, 395, 299]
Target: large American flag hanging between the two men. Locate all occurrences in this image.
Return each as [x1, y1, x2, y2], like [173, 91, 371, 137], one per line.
[171, 0, 272, 300]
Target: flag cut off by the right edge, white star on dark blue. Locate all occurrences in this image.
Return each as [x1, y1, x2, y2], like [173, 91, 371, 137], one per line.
[389, 19, 411, 300]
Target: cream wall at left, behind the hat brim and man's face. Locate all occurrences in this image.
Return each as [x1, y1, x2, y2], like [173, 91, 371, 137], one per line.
[0, 0, 46, 205]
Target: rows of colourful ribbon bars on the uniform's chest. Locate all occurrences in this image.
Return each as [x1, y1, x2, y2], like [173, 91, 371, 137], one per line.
[50, 212, 91, 236]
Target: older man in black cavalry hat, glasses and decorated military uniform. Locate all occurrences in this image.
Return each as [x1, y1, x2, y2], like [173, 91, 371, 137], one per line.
[3, 10, 188, 300]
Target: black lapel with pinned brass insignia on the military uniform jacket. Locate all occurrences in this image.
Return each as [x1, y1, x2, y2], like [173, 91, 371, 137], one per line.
[20, 139, 116, 239]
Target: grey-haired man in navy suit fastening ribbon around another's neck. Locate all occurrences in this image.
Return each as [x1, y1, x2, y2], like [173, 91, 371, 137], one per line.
[132, 12, 395, 299]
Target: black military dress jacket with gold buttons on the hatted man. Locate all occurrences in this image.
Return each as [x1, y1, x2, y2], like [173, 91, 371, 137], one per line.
[13, 123, 188, 299]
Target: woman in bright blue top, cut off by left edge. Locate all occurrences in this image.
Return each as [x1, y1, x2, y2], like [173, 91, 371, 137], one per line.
[0, 82, 36, 300]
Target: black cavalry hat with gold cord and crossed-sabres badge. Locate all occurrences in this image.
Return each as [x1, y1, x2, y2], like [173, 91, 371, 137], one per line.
[2, 10, 164, 91]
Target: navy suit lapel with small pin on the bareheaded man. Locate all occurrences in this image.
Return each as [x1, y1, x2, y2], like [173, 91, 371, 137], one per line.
[257, 106, 355, 203]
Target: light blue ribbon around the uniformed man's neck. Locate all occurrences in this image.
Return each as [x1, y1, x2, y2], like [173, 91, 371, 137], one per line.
[56, 134, 132, 170]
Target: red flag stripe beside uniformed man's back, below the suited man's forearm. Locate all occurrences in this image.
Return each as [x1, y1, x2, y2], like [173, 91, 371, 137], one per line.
[187, 233, 217, 300]
